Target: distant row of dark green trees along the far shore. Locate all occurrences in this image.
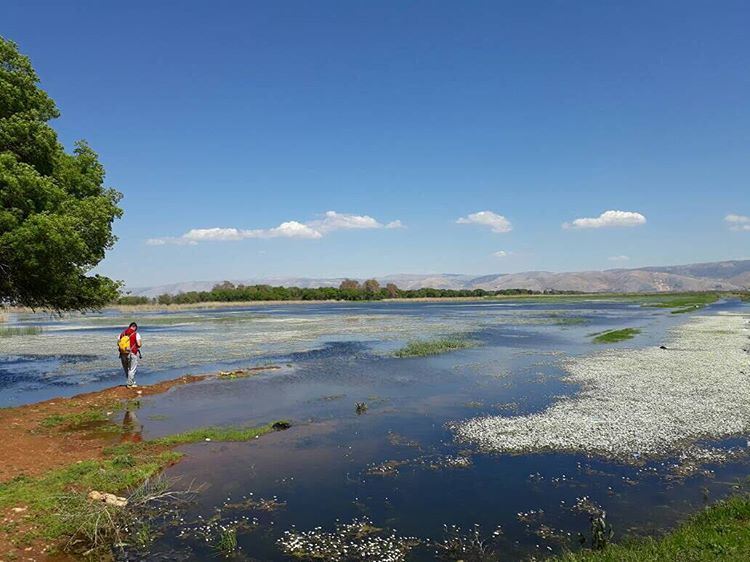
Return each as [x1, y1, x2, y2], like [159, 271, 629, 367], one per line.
[118, 279, 573, 304]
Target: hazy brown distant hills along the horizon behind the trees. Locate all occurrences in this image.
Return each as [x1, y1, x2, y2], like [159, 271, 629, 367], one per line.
[130, 260, 750, 297]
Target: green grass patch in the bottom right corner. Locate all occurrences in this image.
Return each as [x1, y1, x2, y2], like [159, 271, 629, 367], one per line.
[555, 495, 750, 562]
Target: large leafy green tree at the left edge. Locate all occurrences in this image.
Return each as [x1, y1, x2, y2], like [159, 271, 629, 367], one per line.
[0, 37, 122, 311]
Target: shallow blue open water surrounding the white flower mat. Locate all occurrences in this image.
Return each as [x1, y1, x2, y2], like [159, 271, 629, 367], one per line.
[0, 301, 748, 560]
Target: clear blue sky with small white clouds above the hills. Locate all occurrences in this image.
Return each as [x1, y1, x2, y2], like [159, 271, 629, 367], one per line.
[5, 0, 750, 286]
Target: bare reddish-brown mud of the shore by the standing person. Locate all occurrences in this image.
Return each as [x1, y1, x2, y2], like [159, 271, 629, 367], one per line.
[0, 366, 278, 561]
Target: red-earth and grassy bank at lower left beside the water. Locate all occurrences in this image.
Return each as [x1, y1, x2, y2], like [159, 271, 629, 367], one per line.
[0, 377, 290, 560]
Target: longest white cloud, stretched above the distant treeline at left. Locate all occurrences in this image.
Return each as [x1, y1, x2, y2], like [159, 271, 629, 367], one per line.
[146, 211, 404, 246]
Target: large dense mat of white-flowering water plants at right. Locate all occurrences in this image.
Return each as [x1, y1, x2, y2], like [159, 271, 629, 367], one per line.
[450, 314, 750, 463]
